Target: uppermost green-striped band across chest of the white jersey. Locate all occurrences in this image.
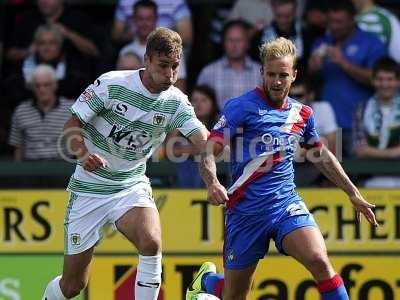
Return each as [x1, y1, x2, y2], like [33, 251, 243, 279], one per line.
[108, 85, 180, 115]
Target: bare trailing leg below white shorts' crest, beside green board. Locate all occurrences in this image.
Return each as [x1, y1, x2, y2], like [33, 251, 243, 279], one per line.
[62, 247, 94, 288]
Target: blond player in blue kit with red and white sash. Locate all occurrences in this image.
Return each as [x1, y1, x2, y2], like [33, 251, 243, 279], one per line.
[186, 38, 378, 300]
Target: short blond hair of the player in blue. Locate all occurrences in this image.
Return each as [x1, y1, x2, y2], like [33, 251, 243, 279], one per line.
[260, 37, 296, 67]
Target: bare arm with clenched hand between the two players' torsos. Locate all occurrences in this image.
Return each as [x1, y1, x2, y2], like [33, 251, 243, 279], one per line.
[190, 130, 228, 205]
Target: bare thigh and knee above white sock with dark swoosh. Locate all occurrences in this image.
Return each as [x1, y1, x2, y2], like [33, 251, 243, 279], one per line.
[115, 207, 161, 255]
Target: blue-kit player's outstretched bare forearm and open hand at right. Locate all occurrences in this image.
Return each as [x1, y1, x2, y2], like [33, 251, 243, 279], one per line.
[310, 146, 378, 226]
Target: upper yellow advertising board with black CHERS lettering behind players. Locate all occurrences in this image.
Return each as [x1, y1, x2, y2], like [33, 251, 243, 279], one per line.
[0, 189, 400, 255]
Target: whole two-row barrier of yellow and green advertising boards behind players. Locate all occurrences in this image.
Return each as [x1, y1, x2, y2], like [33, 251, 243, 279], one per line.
[0, 189, 400, 300]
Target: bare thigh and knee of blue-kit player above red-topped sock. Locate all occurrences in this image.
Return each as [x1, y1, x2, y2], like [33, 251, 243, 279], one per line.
[282, 226, 334, 280]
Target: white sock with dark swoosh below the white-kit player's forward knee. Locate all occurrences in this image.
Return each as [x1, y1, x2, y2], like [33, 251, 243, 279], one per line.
[135, 254, 161, 300]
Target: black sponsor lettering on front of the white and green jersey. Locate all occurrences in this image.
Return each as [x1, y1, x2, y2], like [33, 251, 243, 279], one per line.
[108, 125, 152, 152]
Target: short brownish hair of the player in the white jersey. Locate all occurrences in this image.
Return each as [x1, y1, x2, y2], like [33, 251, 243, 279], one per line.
[146, 27, 182, 57]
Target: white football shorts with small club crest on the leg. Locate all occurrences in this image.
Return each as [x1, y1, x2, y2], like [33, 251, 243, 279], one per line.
[64, 183, 157, 255]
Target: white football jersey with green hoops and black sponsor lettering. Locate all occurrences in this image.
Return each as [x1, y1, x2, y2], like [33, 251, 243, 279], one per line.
[67, 70, 204, 197]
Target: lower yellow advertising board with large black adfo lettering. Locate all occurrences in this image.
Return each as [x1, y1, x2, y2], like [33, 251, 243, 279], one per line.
[88, 256, 400, 300]
